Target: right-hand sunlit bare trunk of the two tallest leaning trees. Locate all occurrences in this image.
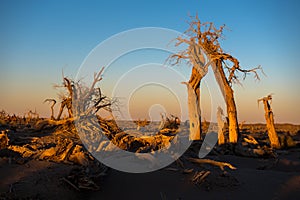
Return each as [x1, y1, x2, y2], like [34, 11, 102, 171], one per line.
[213, 60, 239, 144]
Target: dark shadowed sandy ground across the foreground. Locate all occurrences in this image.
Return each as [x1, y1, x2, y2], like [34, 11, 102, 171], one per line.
[0, 149, 300, 199]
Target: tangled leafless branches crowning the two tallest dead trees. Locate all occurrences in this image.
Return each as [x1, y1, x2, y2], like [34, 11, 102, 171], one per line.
[170, 15, 263, 84]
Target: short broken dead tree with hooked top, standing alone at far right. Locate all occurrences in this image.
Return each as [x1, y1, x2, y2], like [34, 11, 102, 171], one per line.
[257, 94, 280, 149]
